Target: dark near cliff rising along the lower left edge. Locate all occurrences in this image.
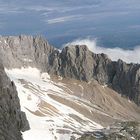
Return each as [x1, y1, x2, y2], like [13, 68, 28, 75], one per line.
[0, 64, 29, 140]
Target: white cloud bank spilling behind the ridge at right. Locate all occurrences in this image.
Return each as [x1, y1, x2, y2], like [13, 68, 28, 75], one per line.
[64, 38, 140, 63]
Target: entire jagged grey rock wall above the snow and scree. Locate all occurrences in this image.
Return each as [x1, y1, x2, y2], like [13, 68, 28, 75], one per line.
[0, 35, 140, 105]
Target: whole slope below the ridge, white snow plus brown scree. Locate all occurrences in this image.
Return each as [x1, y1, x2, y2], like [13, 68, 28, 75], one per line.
[5, 67, 140, 140]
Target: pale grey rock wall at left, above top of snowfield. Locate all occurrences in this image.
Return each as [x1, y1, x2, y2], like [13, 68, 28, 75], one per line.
[0, 35, 54, 70]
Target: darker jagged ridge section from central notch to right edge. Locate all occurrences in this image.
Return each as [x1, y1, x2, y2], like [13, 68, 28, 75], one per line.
[48, 45, 140, 105]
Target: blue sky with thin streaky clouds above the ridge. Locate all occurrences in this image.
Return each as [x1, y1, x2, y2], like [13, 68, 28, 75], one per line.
[0, 0, 140, 47]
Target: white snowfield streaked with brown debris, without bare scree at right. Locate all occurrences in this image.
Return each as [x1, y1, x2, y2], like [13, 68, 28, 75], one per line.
[5, 67, 103, 140]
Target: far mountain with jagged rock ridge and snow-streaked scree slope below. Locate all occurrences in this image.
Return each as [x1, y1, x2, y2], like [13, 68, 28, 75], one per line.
[0, 35, 140, 140]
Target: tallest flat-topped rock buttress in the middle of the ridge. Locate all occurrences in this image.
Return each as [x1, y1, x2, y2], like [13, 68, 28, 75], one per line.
[59, 45, 94, 81]
